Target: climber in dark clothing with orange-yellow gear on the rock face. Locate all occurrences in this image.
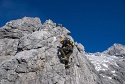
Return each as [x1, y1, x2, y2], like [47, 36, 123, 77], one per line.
[59, 37, 74, 67]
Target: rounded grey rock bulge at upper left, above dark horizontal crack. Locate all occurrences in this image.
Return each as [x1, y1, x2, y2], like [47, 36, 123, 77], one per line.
[0, 17, 42, 39]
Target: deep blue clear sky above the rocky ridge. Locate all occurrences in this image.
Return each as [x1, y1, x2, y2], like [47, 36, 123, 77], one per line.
[0, 0, 125, 52]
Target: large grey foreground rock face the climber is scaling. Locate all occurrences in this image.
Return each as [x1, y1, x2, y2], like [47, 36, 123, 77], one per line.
[0, 17, 101, 84]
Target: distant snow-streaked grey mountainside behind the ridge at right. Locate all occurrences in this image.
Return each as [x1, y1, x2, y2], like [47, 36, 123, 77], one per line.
[86, 44, 125, 84]
